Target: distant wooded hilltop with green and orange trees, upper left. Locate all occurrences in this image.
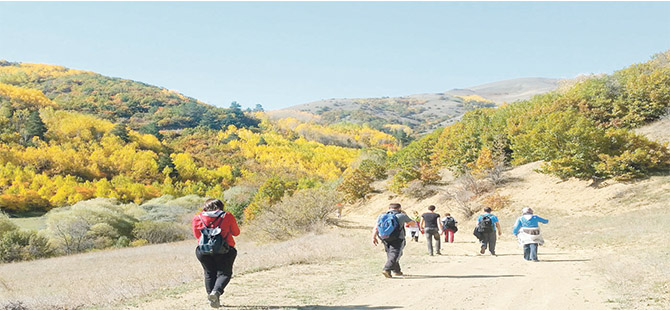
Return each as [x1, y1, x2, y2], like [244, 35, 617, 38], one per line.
[0, 60, 258, 130]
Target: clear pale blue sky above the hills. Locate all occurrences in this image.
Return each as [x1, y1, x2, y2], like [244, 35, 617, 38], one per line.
[0, 2, 670, 110]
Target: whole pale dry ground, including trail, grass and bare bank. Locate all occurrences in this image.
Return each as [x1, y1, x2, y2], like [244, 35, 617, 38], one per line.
[0, 156, 670, 309]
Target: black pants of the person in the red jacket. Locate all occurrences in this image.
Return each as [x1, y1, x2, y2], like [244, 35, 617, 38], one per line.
[195, 247, 237, 294]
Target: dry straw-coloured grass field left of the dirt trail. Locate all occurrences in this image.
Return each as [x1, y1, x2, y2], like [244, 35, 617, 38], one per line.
[0, 226, 372, 309]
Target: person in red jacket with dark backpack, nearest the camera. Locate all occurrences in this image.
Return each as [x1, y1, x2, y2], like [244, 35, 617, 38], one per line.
[193, 199, 240, 308]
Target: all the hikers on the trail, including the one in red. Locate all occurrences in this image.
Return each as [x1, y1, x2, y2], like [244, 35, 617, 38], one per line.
[186, 199, 548, 308]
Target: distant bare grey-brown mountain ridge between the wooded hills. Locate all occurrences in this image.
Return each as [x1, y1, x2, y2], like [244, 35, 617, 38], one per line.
[280, 78, 560, 133]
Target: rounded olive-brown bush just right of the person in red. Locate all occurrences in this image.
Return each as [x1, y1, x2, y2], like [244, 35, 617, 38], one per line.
[249, 188, 340, 240]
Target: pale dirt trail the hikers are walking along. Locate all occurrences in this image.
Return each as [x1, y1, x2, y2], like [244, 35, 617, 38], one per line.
[123, 216, 616, 310]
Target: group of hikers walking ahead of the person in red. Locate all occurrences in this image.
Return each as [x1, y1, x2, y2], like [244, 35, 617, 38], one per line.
[372, 203, 549, 278]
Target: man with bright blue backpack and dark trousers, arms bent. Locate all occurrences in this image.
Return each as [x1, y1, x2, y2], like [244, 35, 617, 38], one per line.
[372, 203, 412, 278]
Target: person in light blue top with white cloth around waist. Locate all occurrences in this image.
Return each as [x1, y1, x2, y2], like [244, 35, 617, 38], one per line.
[512, 207, 549, 262]
